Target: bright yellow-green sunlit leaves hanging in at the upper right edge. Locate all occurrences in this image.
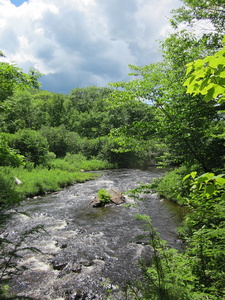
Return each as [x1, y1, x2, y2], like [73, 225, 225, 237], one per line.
[184, 37, 225, 168]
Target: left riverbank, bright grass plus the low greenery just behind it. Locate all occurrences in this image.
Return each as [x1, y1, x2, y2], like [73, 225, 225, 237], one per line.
[0, 155, 113, 206]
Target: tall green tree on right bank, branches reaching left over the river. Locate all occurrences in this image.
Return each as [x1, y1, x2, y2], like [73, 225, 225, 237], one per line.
[108, 31, 224, 171]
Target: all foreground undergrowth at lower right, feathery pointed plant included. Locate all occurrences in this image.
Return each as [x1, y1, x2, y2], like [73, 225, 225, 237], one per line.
[126, 170, 225, 300]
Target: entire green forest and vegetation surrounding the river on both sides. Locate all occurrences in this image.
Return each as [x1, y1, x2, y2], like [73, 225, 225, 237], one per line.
[0, 0, 225, 300]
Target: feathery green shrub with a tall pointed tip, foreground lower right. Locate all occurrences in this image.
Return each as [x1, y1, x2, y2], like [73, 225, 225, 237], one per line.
[127, 214, 196, 300]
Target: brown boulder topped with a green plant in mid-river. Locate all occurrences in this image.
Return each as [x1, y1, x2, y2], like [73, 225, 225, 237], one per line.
[90, 189, 125, 207]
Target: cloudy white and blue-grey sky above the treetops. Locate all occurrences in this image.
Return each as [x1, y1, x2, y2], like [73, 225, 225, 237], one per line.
[0, 0, 182, 94]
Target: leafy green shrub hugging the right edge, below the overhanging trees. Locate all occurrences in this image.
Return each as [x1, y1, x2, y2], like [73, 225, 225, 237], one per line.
[181, 172, 225, 299]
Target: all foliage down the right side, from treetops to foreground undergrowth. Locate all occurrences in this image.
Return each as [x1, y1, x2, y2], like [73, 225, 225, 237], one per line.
[106, 0, 225, 300]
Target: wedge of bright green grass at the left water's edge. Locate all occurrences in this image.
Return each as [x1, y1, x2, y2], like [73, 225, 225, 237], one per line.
[0, 167, 98, 204]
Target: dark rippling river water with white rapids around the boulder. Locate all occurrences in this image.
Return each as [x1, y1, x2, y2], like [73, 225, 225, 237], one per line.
[2, 169, 186, 300]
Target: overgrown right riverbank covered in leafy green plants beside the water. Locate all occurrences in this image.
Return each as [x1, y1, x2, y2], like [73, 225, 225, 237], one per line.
[139, 166, 225, 300]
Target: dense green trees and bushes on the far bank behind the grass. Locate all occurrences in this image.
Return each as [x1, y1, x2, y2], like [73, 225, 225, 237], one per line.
[0, 87, 156, 167]
